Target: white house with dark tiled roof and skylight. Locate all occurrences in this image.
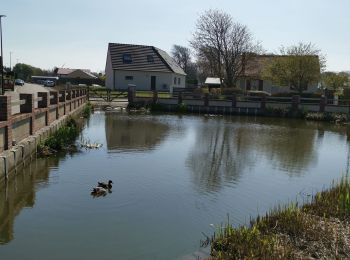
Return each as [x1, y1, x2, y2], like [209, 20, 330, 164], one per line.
[105, 43, 186, 92]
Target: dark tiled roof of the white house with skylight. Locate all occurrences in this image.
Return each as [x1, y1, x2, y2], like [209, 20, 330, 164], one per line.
[108, 43, 186, 75]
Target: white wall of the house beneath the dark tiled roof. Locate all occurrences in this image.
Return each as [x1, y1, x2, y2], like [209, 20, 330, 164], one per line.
[110, 70, 186, 92]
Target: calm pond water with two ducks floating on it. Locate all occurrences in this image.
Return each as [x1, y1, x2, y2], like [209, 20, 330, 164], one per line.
[0, 113, 350, 260]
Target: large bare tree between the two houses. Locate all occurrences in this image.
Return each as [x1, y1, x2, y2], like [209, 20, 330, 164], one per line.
[191, 10, 258, 87]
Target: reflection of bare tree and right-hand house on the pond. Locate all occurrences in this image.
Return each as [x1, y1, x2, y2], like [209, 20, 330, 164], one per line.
[187, 117, 346, 192]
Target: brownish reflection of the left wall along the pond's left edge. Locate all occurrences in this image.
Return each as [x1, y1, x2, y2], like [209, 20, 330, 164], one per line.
[0, 157, 59, 244]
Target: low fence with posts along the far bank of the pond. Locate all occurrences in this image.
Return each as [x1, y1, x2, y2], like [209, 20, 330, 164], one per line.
[128, 87, 350, 114]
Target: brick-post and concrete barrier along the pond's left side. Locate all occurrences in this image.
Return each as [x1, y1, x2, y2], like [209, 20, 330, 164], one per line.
[0, 88, 87, 152]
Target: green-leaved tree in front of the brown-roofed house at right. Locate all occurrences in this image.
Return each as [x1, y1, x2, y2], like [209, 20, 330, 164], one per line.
[263, 43, 326, 94]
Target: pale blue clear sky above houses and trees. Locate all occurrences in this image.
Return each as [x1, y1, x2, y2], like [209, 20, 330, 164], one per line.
[0, 0, 350, 72]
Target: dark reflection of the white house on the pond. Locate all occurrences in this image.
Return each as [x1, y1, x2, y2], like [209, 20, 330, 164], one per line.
[105, 113, 169, 152]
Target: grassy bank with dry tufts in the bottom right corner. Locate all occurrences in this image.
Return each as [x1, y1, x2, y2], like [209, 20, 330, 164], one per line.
[208, 178, 350, 259]
